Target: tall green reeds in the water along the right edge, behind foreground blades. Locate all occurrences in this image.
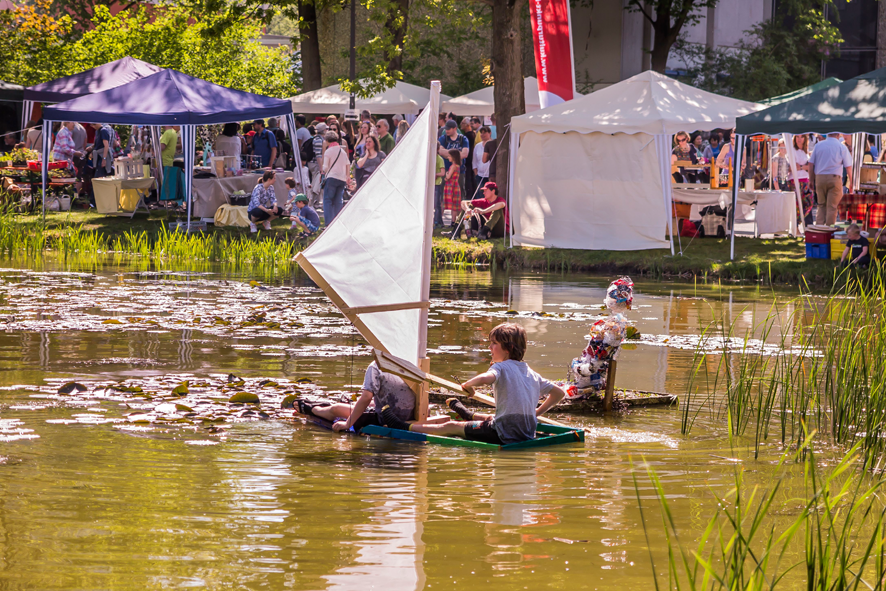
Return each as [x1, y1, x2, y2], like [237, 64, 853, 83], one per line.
[682, 269, 886, 470]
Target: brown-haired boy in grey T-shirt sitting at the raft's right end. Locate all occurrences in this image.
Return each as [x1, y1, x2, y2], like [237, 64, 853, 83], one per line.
[381, 323, 566, 445]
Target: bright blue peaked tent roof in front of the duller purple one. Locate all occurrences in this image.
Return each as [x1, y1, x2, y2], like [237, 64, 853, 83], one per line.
[43, 70, 292, 125]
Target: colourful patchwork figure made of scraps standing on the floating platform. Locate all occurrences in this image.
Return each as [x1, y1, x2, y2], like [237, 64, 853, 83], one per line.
[567, 277, 634, 396]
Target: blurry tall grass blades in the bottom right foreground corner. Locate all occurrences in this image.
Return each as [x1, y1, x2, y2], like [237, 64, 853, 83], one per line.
[634, 438, 886, 591]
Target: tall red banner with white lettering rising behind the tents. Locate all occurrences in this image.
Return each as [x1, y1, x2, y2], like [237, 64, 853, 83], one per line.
[529, 0, 575, 109]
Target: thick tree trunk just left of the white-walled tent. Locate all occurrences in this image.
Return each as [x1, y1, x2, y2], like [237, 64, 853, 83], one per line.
[492, 0, 529, 206]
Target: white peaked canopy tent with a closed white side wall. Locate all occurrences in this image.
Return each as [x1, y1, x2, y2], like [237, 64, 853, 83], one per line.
[509, 71, 762, 253]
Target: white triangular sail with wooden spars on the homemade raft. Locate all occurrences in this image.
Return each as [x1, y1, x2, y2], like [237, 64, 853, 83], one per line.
[296, 82, 440, 364]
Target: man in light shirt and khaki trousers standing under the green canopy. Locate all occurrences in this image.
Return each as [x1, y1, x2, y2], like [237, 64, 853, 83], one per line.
[809, 133, 852, 226]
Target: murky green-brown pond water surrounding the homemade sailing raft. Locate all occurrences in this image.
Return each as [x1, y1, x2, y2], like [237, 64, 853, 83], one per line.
[0, 264, 824, 591]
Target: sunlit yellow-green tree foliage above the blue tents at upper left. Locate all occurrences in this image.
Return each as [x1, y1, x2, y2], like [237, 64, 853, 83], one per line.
[0, 4, 298, 97]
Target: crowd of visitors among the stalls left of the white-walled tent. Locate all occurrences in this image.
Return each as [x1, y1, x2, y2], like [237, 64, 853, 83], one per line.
[3, 110, 509, 239]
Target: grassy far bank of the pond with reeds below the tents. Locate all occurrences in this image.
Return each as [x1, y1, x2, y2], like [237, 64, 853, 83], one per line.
[0, 210, 872, 287]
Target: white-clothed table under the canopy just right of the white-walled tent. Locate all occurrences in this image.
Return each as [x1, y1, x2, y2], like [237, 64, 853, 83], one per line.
[673, 189, 797, 237]
